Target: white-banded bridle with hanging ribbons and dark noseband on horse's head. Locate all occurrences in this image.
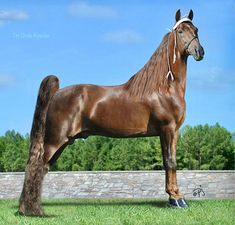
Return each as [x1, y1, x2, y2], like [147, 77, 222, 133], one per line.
[166, 17, 198, 81]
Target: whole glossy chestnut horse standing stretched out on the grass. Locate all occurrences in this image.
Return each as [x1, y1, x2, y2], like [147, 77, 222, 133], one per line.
[19, 10, 204, 215]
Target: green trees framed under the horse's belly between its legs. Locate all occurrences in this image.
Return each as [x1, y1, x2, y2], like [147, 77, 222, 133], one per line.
[53, 136, 162, 170]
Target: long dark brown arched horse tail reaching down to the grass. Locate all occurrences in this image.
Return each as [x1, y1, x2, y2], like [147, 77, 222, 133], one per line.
[19, 76, 59, 215]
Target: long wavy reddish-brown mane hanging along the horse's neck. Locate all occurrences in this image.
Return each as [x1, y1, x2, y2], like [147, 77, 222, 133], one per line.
[124, 33, 170, 98]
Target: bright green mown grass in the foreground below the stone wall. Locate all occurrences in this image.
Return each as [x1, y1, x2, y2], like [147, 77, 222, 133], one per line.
[0, 199, 235, 225]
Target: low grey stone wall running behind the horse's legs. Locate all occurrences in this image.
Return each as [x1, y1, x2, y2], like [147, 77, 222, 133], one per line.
[0, 171, 235, 199]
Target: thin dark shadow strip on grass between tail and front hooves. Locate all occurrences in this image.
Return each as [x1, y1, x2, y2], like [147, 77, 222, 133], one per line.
[43, 200, 167, 208]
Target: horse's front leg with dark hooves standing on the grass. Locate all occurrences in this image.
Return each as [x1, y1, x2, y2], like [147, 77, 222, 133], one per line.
[160, 128, 187, 208]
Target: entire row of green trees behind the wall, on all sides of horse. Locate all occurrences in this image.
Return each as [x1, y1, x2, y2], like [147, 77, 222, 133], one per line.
[0, 124, 235, 172]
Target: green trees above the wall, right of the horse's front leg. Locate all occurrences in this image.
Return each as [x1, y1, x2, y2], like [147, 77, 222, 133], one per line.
[177, 124, 235, 170]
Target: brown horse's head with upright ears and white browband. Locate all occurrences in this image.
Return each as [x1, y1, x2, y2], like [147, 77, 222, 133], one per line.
[173, 10, 204, 61]
